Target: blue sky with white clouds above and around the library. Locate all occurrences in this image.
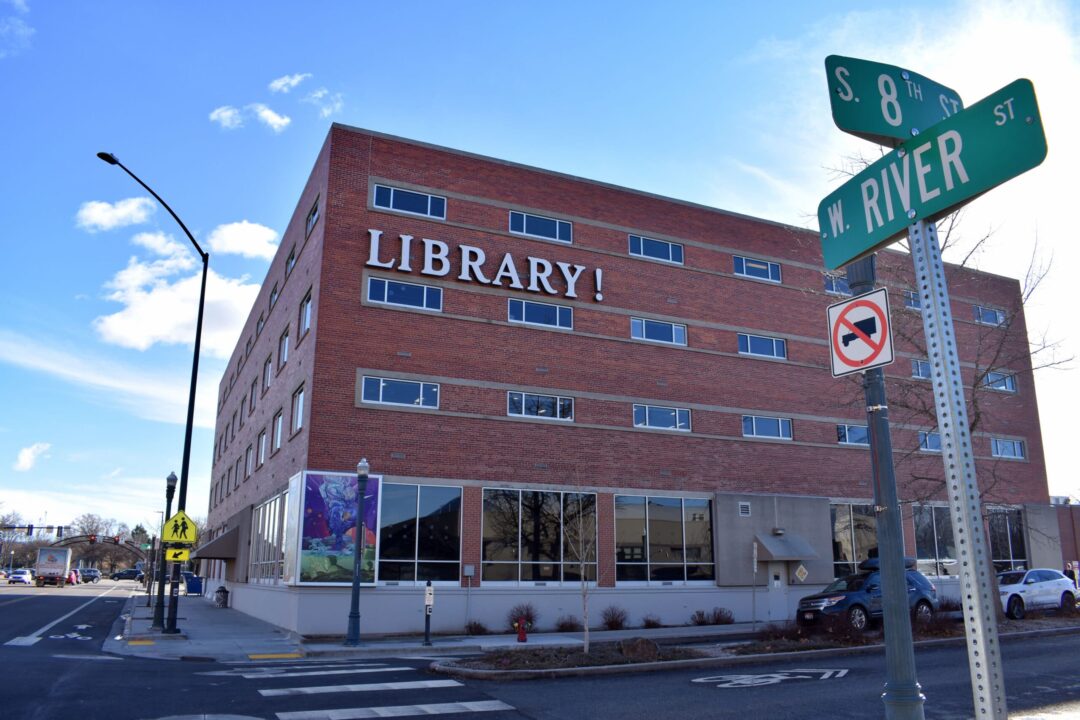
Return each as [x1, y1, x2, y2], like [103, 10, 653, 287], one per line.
[0, 0, 1080, 525]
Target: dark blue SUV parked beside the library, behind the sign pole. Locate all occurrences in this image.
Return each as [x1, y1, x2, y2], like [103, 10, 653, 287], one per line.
[795, 558, 937, 633]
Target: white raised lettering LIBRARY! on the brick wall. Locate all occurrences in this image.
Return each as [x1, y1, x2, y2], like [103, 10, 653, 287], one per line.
[366, 229, 604, 302]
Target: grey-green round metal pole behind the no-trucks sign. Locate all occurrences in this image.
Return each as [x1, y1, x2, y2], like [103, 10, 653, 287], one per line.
[848, 255, 926, 720]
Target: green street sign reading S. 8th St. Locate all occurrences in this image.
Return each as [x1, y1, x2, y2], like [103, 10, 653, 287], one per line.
[825, 55, 963, 148]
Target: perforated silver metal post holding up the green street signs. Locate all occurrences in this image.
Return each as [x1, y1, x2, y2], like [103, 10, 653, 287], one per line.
[907, 220, 1009, 720]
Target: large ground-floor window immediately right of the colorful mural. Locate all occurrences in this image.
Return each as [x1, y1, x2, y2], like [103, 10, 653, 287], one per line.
[378, 483, 461, 584]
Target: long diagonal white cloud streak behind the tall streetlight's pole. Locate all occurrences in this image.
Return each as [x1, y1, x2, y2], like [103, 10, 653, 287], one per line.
[0, 321, 220, 427]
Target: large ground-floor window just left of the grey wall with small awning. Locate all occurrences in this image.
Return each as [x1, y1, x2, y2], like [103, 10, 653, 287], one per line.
[615, 495, 716, 585]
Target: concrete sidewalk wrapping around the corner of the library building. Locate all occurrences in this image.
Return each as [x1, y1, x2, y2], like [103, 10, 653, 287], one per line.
[104, 594, 761, 662]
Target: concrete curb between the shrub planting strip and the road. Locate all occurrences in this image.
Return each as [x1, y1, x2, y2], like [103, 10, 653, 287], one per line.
[429, 626, 1080, 680]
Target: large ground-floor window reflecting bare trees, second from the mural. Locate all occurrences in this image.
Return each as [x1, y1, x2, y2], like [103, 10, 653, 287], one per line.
[481, 489, 596, 584]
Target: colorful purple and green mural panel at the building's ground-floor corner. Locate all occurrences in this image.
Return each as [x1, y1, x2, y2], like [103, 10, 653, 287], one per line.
[299, 473, 379, 584]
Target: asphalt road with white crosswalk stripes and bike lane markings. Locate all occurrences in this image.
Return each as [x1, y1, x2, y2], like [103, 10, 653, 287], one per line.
[0, 581, 1080, 720]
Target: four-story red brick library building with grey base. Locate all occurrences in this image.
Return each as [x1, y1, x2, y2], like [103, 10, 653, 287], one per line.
[197, 124, 1061, 635]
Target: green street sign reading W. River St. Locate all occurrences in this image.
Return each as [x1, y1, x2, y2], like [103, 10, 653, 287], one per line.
[818, 80, 1047, 270]
